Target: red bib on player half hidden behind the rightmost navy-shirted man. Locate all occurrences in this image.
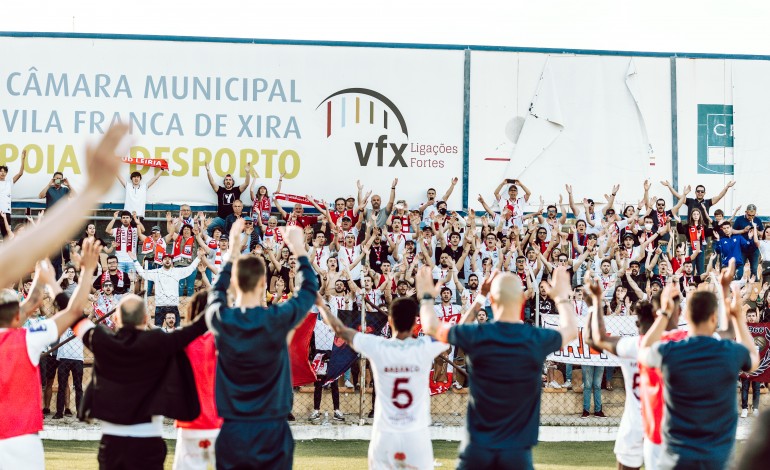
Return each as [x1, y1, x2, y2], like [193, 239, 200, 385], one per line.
[639, 330, 689, 444]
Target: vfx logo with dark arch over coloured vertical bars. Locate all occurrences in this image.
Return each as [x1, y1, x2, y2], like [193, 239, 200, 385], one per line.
[316, 88, 409, 167]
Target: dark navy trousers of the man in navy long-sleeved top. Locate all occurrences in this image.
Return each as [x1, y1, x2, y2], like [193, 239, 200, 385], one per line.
[216, 419, 294, 470]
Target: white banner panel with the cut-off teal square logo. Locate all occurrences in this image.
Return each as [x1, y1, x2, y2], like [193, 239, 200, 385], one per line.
[676, 59, 741, 213]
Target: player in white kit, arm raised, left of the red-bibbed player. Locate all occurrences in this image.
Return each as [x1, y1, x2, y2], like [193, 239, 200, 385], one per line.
[586, 279, 655, 470]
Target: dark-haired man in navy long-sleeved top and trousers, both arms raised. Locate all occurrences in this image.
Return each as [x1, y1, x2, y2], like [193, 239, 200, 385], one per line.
[206, 219, 318, 469]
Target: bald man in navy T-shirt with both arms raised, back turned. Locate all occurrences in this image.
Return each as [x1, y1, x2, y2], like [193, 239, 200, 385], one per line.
[416, 267, 577, 469]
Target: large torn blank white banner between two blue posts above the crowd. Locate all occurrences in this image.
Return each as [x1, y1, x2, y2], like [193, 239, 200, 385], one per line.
[469, 51, 671, 210]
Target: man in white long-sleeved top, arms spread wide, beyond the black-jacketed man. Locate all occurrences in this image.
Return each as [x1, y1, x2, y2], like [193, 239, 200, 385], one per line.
[129, 251, 203, 327]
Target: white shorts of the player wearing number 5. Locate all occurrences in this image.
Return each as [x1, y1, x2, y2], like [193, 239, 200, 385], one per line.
[369, 429, 433, 470]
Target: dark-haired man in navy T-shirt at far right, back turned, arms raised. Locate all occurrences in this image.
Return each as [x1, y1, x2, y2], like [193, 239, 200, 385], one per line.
[639, 262, 759, 470]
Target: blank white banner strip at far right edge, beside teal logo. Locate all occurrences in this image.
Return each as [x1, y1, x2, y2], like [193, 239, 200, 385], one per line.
[733, 60, 770, 212]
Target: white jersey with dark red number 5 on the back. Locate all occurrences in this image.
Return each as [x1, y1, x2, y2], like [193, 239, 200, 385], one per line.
[353, 333, 449, 433]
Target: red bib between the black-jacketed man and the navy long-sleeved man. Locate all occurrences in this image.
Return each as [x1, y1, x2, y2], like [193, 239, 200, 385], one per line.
[176, 332, 223, 429]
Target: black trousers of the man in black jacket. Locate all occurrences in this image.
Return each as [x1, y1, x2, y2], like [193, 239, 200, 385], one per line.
[96, 435, 166, 470]
